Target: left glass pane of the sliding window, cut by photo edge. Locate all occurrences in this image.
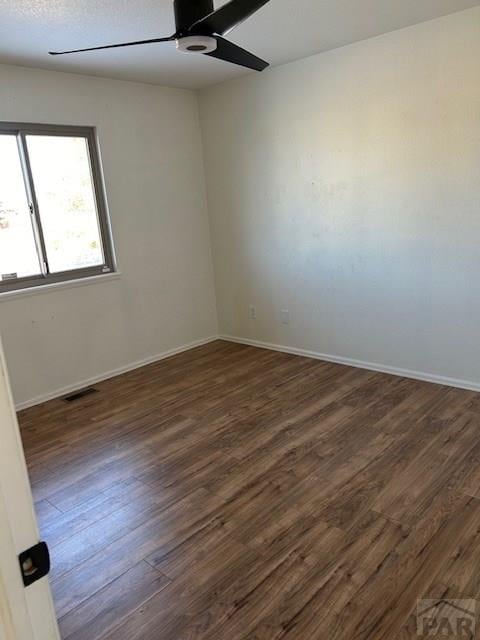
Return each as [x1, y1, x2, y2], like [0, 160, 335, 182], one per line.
[0, 135, 41, 281]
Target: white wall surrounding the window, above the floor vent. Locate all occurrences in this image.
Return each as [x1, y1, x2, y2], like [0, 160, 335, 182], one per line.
[0, 66, 217, 403]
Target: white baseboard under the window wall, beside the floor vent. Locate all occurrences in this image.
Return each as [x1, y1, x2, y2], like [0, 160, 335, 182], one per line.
[15, 336, 218, 411]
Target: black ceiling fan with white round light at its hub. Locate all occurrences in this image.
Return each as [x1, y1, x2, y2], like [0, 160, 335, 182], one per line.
[49, 0, 269, 71]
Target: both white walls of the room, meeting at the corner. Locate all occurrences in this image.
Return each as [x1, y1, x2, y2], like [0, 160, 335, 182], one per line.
[0, 8, 480, 404]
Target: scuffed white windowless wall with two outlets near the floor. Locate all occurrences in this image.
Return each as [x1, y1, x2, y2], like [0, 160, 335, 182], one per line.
[200, 8, 480, 385]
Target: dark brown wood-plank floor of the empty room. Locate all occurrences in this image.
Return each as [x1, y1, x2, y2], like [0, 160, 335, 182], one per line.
[20, 341, 480, 640]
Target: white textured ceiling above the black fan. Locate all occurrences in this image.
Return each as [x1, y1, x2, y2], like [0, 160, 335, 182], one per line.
[0, 0, 480, 88]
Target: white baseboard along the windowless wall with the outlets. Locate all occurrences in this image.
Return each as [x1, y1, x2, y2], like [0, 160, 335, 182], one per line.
[218, 335, 480, 392]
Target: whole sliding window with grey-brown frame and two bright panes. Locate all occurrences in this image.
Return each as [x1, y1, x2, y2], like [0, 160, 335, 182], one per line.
[0, 123, 114, 293]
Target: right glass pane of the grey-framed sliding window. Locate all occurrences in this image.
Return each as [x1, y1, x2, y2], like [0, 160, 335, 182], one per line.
[27, 135, 104, 273]
